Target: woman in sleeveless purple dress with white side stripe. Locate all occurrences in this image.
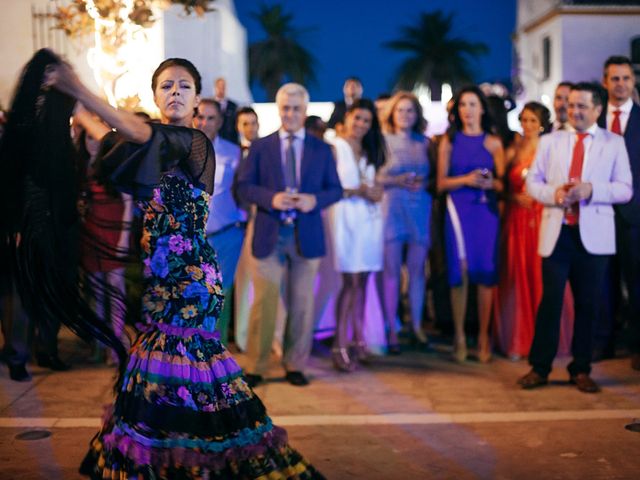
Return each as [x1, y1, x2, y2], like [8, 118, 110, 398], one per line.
[438, 86, 504, 363]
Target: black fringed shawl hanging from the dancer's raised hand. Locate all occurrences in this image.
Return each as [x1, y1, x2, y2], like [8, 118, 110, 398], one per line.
[0, 49, 126, 376]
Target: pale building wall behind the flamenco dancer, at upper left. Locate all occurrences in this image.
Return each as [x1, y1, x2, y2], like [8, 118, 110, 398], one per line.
[0, 0, 252, 108]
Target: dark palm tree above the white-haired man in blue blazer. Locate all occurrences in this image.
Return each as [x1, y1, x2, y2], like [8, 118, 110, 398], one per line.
[249, 5, 315, 101]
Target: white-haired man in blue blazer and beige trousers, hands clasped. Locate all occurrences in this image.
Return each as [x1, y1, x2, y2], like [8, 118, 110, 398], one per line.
[236, 83, 342, 387]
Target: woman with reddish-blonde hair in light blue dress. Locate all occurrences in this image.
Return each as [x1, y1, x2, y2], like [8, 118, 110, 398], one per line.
[377, 91, 431, 354]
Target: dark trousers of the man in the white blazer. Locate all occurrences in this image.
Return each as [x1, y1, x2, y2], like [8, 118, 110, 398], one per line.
[529, 225, 609, 377]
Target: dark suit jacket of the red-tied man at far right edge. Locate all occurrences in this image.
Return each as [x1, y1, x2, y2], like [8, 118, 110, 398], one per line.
[598, 103, 640, 226]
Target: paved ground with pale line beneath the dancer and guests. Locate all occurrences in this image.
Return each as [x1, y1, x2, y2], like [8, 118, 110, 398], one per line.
[0, 330, 640, 480]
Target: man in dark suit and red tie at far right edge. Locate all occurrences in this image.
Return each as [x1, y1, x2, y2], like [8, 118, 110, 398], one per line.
[598, 56, 640, 370]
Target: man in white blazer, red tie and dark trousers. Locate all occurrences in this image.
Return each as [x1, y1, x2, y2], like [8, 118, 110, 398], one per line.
[518, 83, 632, 393]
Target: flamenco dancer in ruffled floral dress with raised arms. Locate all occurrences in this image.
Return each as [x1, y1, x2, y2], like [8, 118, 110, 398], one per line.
[2, 50, 323, 480]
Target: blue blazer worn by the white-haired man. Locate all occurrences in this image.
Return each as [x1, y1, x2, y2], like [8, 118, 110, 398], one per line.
[236, 132, 342, 258]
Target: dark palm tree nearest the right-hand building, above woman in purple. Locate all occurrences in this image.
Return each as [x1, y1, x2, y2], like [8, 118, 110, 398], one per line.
[384, 10, 489, 100]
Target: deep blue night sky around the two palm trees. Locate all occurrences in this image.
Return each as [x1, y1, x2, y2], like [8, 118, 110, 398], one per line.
[235, 0, 516, 102]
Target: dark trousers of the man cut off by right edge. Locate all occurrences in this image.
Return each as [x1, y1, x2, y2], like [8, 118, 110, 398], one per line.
[616, 219, 640, 353]
